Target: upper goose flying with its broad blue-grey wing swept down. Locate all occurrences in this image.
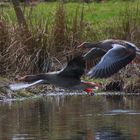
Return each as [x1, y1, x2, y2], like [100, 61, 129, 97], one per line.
[78, 39, 140, 78]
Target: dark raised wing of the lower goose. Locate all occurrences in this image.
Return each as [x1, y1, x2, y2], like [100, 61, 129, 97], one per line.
[59, 56, 85, 79]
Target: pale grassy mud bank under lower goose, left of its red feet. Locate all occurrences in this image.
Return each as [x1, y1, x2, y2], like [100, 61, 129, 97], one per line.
[0, 77, 86, 100]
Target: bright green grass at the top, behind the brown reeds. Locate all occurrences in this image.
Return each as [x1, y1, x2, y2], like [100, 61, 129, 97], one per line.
[1, 1, 137, 24]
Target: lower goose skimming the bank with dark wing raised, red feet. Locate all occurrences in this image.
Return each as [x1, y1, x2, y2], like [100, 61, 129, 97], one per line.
[10, 56, 98, 93]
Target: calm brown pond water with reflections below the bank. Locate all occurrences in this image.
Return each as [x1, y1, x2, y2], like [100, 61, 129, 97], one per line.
[0, 95, 140, 140]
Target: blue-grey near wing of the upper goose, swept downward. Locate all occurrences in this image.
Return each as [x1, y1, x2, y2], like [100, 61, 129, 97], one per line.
[88, 44, 136, 78]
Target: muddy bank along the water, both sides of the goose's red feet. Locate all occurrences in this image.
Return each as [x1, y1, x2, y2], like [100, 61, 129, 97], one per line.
[0, 77, 140, 100]
